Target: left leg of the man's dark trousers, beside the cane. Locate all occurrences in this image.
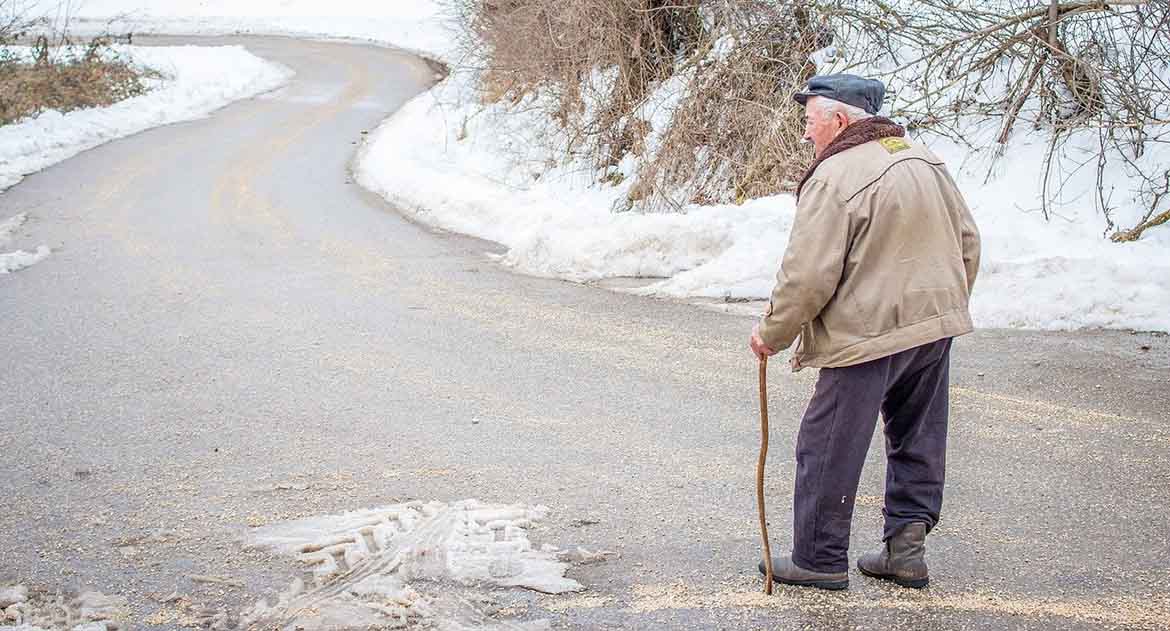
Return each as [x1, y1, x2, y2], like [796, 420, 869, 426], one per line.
[792, 359, 889, 572]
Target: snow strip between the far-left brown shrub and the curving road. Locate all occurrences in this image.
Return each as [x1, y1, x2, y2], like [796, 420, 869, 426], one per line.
[0, 46, 291, 191]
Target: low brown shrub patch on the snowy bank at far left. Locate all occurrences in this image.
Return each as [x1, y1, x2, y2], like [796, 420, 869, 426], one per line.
[0, 37, 146, 124]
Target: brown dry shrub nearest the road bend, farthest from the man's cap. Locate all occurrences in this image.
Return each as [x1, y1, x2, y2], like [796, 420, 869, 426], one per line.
[459, 0, 704, 175]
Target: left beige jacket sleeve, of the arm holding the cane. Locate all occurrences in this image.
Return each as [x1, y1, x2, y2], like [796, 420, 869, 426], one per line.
[759, 178, 849, 350]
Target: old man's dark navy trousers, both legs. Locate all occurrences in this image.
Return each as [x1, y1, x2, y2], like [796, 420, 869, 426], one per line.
[792, 338, 951, 572]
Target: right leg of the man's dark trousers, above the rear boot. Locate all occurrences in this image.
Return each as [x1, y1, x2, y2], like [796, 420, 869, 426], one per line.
[882, 339, 951, 540]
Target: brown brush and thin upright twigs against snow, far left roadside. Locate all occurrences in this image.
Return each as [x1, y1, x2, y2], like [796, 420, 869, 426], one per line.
[0, 0, 147, 125]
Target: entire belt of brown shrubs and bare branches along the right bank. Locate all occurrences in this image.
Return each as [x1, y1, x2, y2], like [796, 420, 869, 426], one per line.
[455, 0, 1170, 241]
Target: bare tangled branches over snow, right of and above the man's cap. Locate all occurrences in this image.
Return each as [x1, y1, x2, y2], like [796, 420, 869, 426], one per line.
[820, 0, 1170, 240]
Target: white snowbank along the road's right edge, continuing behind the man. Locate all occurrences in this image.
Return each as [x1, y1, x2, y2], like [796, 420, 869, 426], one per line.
[359, 66, 1170, 330]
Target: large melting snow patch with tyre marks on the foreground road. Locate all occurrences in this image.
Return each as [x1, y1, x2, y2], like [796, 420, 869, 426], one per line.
[241, 500, 584, 631]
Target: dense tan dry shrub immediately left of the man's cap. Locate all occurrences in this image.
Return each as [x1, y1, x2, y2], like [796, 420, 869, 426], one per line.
[629, 2, 831, 208]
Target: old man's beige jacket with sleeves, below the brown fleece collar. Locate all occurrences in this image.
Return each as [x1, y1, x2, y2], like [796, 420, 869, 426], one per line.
[759, 138, 979, 370]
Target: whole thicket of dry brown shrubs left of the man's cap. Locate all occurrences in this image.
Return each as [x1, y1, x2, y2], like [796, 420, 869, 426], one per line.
[459, 0, 830, 211]
